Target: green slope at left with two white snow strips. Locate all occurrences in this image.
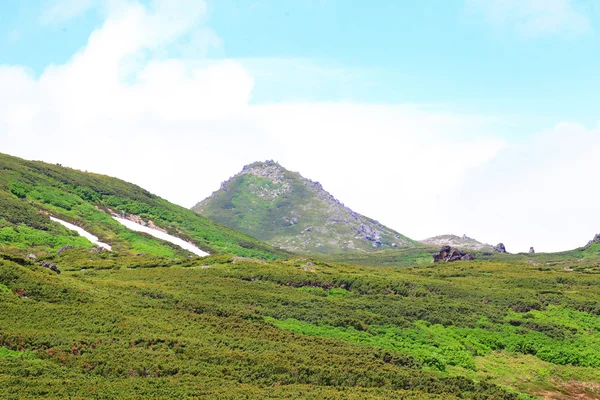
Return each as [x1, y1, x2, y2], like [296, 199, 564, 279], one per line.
[0, 154, 285, 259]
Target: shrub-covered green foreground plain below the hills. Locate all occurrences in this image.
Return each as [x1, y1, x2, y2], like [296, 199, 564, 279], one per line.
[0, 245, 600, 399]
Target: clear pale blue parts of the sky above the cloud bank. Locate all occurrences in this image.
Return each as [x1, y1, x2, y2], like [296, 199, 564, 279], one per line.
[0, 0, 600, 128]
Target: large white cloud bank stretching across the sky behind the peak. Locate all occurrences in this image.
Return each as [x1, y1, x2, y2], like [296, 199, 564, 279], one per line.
[0, 0, 600, 250]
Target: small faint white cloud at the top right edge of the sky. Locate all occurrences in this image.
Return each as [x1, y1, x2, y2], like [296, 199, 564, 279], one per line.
[466, 0, 592, 37]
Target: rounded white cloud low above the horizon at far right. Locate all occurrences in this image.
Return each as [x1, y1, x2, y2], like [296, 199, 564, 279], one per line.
[447, 123, 600, 251]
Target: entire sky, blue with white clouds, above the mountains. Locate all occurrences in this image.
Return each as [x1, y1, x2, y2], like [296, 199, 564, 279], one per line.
[0, 0, 600, 252]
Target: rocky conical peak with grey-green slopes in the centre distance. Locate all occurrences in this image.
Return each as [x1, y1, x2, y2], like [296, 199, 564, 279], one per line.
[192, 161, 419, 254]
